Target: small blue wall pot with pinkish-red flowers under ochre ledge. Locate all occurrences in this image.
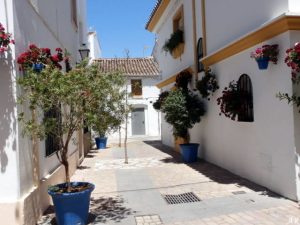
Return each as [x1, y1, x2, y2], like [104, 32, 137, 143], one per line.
[251, 45, 279, 70]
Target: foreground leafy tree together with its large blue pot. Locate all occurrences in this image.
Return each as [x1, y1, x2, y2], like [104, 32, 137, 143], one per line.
[18, 55, 106, 225]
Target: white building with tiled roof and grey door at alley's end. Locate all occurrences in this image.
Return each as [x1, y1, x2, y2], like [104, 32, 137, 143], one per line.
[95, 57, 161, 138]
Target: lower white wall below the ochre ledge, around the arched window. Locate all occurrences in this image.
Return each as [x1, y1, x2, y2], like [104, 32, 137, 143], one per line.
[199, 33, 297, 199]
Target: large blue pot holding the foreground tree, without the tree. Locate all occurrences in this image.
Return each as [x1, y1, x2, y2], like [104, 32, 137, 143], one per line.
[48, 182, 95, 225]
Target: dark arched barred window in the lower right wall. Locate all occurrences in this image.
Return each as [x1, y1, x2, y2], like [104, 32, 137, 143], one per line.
[237, 74, 254, 122]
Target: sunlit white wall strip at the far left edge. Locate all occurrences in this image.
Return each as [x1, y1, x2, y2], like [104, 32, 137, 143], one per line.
[0, 1, 19, 203]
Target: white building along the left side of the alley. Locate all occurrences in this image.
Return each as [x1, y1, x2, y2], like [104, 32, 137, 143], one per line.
[0, 0, 87, 225]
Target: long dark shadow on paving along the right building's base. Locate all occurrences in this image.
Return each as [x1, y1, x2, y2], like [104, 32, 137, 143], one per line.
[144, 141, 281, 198]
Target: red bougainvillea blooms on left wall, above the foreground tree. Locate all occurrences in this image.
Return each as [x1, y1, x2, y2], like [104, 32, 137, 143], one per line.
[17, 44, 69, 70]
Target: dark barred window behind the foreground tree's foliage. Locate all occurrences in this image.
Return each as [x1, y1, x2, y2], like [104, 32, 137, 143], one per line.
[44, 108, 61, 157]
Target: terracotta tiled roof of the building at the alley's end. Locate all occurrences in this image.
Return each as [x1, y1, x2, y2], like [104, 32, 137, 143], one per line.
[94, 57, 159, 77]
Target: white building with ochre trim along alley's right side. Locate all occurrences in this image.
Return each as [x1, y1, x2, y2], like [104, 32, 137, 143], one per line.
[146, 0, 300, 200]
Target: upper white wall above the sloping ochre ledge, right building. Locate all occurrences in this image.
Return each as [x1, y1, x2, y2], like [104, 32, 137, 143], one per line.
[206, 0, 289, 54]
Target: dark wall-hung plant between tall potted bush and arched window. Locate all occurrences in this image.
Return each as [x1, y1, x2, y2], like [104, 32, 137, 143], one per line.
[196, 68, 219, 100]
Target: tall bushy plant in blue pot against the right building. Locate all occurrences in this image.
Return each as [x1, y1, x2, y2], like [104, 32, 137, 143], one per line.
[154, 71, 205, 163]
